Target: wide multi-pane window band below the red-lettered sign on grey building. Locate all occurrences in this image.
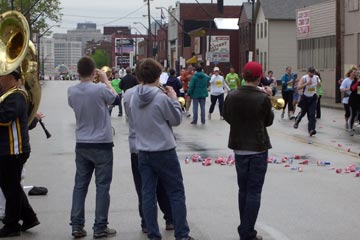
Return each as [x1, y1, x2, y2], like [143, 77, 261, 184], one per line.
[298, 36, 336, 69]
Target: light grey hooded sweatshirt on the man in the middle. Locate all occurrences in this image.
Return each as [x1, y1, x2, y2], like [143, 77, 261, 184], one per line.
[129, 85, 182, 152]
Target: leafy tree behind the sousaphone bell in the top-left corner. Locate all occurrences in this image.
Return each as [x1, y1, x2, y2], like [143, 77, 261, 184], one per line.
[0, 0, 62, 34]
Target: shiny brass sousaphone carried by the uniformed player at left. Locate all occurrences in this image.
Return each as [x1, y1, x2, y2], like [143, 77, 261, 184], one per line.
[0, 11, 41, 124]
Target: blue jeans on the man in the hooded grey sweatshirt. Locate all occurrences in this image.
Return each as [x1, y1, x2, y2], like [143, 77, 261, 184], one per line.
[139, 149, 190, 238]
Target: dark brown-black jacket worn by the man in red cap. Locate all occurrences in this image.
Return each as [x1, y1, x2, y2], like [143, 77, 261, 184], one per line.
[224, 86, 274, 152]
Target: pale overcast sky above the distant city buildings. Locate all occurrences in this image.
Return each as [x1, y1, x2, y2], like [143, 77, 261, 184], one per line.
[53, 0, 247, 33]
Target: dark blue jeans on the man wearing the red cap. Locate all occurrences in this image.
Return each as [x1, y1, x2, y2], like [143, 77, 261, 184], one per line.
[235, 151, 268, 240]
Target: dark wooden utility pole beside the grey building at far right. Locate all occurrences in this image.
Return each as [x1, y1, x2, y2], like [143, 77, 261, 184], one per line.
[335, 0, 344, 103]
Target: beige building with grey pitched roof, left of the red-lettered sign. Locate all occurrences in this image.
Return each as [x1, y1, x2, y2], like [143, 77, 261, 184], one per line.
[255, 0, 328, 78]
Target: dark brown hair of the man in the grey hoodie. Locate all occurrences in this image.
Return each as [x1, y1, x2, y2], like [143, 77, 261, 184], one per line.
[135, 58, 163, 84]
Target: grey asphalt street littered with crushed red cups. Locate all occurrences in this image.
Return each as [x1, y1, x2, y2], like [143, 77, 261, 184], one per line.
[1, 81, 360, 240]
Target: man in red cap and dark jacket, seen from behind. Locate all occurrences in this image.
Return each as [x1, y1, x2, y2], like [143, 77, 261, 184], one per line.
[224, 62, 274, 240]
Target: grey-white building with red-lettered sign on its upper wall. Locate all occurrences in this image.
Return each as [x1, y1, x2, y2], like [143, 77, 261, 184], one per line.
[297, 0, 336, 97]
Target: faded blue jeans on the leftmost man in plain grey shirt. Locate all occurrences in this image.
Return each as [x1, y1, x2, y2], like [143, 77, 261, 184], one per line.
[70, 148, 113, 233]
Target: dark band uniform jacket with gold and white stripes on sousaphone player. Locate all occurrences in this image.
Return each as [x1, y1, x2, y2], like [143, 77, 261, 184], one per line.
[0, 92, 30, 156]
